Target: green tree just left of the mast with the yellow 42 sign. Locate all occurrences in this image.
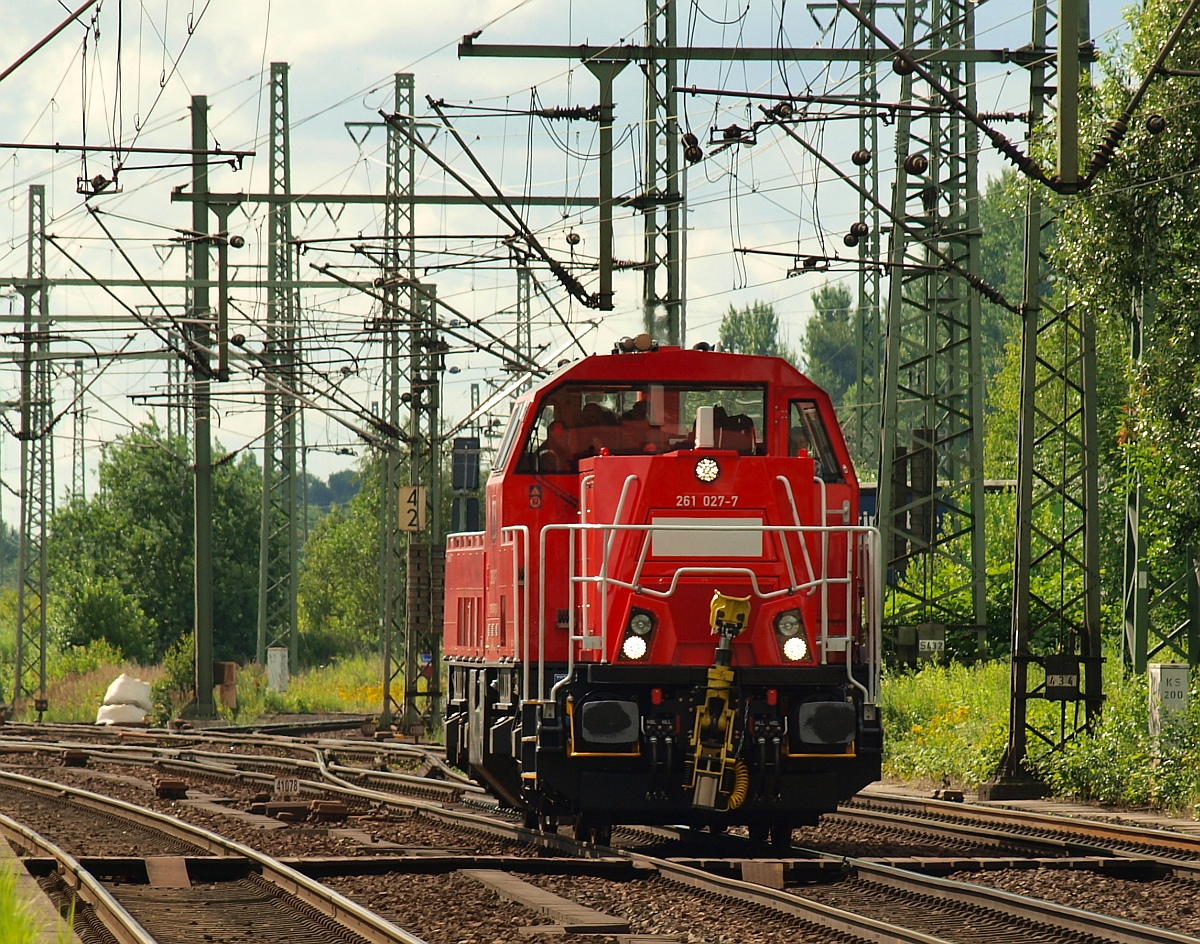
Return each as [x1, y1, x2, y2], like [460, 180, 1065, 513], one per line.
[299, 464, 380, 665]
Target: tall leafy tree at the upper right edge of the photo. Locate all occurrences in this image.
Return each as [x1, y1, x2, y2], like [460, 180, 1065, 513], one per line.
[1056, 0, 1200, 554]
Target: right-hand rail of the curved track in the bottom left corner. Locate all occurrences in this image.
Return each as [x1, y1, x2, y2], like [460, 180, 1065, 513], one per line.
[0, 770, 425, 944]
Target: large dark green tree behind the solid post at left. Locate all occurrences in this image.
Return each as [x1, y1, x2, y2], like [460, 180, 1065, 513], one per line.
[49, 423, 262, 659]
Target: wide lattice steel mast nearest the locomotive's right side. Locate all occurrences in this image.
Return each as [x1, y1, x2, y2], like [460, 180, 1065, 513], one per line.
[878, 0, 986, 642]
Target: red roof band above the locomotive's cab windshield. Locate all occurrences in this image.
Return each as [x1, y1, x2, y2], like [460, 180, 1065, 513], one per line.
[526, 344, 820, 397]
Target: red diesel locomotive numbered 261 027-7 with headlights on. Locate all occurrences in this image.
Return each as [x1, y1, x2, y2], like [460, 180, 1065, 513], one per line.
[444, 335, 883, 844]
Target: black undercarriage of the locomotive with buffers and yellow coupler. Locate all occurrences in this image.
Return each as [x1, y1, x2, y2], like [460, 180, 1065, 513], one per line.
[446, 661, 883, 836]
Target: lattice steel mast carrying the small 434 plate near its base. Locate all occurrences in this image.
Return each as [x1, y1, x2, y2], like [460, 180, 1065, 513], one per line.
[980, 0, 1103, 799]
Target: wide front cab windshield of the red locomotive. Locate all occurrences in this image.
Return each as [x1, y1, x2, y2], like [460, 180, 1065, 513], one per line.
[516, 383, 767, 475]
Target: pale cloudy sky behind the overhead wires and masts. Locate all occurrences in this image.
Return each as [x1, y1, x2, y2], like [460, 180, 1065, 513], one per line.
[0, 0, 1121, 522]
